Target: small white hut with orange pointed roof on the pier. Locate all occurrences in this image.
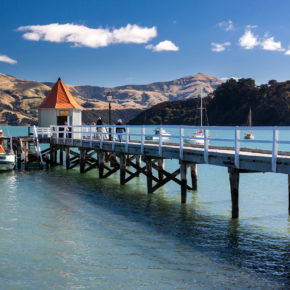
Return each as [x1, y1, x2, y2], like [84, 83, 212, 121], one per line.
[38, 78, 84, 127]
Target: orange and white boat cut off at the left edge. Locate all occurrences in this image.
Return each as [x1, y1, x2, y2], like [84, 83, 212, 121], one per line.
[0, 130, 16, 171]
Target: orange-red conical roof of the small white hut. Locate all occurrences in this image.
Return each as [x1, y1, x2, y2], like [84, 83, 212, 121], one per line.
[39, 78, 84, 109]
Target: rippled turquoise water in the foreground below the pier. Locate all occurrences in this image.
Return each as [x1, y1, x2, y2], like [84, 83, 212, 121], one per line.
[0, 128, 290, 289]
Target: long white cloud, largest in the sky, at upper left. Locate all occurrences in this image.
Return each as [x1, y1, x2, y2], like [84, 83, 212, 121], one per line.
[17, 23, 157, 48]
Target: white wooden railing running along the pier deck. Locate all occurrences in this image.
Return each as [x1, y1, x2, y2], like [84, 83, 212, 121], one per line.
[37, 125, 290, 172]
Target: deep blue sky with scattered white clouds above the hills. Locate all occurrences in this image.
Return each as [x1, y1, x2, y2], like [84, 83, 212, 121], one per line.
[0, 0, 290, 87]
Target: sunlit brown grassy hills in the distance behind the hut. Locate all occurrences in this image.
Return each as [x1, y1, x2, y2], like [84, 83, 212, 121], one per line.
[0, 73, 222, 125]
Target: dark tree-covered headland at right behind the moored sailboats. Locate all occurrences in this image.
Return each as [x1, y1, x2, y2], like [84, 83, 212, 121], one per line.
[129, 79, 290, 126]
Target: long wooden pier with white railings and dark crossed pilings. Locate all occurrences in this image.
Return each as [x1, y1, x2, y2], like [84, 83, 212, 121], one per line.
[14, 126, 290, 218]
